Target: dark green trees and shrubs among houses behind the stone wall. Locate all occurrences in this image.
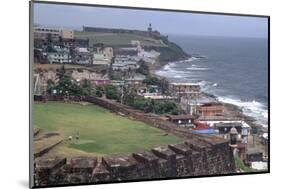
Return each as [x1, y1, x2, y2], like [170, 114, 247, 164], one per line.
[47, 64, 179, 114]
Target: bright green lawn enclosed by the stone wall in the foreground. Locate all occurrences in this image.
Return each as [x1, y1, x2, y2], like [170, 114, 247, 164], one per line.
[34, 102, 181, 156]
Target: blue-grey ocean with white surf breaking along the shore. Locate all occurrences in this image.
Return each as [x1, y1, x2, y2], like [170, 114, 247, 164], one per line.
[156, 36, 269, 127]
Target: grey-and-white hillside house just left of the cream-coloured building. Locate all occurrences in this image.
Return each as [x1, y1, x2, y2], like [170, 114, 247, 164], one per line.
[72, 47, 93, 64]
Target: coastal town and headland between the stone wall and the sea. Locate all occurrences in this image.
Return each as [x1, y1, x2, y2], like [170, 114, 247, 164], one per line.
[33, 24, 268, 185]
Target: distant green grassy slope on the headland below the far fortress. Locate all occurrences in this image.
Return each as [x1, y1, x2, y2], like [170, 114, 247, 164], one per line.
[74, 31, 167, 47]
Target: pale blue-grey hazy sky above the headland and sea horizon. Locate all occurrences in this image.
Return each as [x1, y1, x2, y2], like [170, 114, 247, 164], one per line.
[34, 3, 268, 38]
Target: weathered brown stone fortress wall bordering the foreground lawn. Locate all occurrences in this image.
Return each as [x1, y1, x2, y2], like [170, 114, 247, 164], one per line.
[34, 97, 236, 187]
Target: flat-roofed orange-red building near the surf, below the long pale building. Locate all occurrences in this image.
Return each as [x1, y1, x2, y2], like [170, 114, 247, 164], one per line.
[198, 102, 224, 117]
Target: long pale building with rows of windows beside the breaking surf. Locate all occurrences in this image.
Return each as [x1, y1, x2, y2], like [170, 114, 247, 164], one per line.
[170, 83, 200, 98]
